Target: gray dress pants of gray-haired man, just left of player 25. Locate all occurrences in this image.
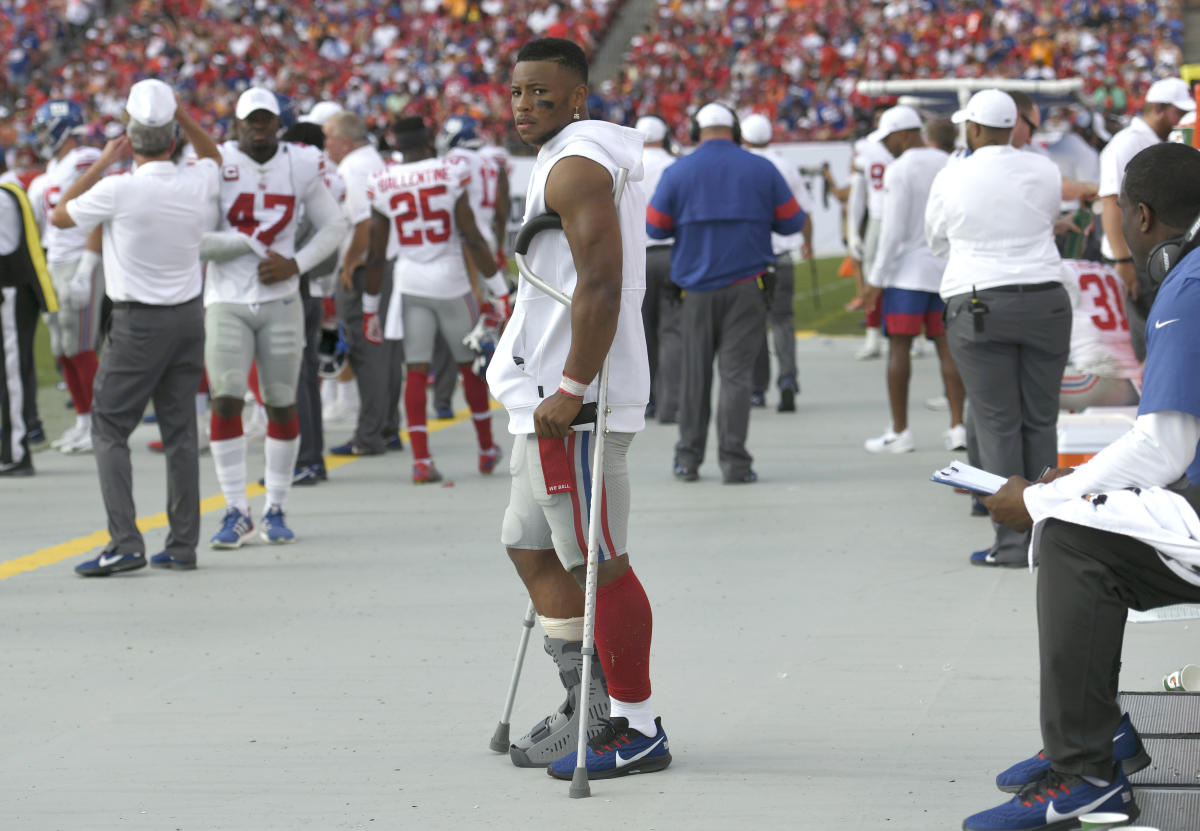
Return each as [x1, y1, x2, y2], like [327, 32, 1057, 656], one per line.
[337, 265, 404, 453]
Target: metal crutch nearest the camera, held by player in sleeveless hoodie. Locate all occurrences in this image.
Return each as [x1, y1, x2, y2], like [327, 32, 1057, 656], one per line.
[514, 168, 629, 799]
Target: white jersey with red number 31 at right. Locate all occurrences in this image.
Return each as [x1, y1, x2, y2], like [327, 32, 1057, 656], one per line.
[1062, 259, 1138, 378]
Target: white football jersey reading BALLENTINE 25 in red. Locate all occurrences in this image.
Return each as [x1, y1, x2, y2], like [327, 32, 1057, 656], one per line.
[367, 156, 470, 299]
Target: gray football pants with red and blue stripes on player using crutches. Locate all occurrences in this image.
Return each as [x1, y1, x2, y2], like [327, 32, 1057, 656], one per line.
[500, 431, 634, 570]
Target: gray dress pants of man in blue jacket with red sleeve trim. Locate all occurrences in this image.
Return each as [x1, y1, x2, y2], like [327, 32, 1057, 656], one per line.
[676, 280, 767, 482]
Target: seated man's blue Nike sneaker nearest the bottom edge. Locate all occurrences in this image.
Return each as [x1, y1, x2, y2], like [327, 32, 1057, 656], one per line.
[962, 765, 1140, 831]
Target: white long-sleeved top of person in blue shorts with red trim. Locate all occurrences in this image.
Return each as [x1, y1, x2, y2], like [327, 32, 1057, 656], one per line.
[866, 148, 950, 292]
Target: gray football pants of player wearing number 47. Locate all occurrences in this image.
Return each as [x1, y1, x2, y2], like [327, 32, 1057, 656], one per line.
[204, 294, 304, 407]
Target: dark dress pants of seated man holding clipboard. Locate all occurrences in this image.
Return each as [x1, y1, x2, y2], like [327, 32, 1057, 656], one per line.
[1037, 520, 1200, 779]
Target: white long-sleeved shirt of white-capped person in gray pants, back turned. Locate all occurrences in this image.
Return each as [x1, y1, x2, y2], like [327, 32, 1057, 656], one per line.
[925, 144, 1062, 299]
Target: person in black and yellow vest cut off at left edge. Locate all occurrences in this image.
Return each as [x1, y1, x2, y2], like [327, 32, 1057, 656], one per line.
[0, 178, 58, 477]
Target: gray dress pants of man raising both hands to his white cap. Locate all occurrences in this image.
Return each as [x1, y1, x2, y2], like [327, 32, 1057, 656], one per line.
[91, 298, 204, 562]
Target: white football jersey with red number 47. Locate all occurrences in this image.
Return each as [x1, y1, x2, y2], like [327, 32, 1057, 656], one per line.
[204, 142, 325, 305]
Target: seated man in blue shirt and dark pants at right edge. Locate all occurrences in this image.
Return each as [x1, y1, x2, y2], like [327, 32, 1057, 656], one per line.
[962, 144, 1200, 831]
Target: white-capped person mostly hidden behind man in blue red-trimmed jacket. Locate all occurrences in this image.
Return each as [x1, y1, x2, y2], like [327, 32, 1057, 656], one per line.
[742, 113, 812, 413]
